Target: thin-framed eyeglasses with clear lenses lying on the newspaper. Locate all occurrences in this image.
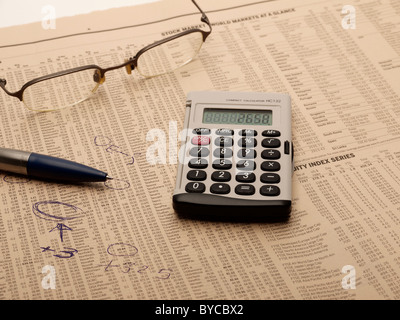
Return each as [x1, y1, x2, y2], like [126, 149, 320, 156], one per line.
[0, 0, 212, 112]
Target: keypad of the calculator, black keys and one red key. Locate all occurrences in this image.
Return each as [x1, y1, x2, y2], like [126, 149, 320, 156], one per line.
[185, 128, 287, 198]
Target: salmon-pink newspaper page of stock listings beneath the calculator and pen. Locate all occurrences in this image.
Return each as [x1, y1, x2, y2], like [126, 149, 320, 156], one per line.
[0, 0, 400, 300]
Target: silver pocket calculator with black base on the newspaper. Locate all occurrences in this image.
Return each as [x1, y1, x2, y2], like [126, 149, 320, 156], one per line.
[173, 91, 293, 220]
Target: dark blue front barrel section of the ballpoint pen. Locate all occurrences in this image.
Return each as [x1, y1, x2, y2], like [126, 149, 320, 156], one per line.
[27, 153, 107, 182]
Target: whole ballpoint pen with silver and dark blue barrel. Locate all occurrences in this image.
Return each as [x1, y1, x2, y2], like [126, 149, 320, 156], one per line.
[0, 148, 112, 182]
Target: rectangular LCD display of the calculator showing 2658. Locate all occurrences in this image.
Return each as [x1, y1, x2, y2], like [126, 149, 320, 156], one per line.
[203, 108, 272, 126]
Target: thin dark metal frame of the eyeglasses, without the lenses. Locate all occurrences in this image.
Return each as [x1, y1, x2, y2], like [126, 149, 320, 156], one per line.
[0, 0, 212, 102]
